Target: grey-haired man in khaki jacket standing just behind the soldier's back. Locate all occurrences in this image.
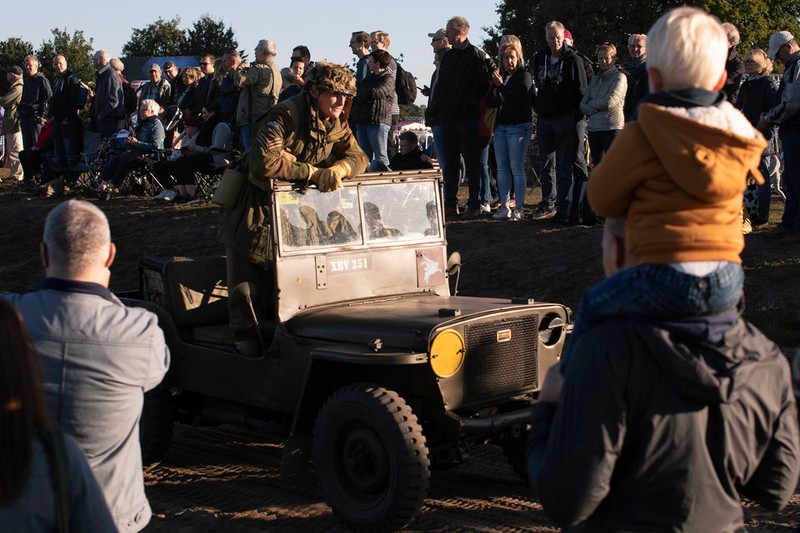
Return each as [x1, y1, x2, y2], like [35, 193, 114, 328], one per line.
[233, 39, 283, 151]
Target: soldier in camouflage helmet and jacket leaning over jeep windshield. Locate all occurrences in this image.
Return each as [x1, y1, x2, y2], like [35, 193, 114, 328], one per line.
[220, 62, 368, 355]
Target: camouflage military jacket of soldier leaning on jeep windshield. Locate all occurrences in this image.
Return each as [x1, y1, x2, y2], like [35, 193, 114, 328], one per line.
[220, 91, 369, 264]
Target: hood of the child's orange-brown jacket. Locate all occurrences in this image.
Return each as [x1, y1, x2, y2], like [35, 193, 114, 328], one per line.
[638, 102, 766, 203]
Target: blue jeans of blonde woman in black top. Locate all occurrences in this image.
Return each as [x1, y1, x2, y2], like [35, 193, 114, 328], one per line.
[494, 122, 531, 207]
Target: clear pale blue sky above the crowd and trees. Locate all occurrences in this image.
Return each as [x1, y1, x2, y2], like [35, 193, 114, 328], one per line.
[0, 0, 498, 104]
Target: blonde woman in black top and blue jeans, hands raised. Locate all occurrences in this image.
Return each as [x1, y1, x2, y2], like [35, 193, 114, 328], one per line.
[488, 39, 533, 220]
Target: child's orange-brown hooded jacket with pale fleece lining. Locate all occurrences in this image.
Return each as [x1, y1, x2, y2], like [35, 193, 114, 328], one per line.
[588, 93, 767, 265]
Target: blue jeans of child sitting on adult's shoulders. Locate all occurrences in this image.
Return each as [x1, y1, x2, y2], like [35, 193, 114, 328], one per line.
[559, 263, 744, 373]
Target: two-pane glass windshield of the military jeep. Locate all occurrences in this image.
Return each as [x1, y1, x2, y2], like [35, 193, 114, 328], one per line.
[276, 179, 442, 252]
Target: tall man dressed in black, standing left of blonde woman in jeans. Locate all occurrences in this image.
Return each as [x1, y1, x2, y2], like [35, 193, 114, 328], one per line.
[431, 17, 489, 220]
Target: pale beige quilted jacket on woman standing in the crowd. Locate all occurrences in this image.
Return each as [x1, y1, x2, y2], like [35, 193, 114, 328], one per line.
[581, 67, 628, 131]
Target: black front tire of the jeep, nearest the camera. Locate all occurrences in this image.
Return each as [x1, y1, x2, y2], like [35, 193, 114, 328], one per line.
[313, 383, 430, 531]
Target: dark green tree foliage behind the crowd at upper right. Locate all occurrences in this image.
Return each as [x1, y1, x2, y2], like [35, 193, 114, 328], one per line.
[483, 0, 800, 67]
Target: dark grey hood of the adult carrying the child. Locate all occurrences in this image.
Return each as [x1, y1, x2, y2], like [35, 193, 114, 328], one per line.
[643, 317, 783, 405]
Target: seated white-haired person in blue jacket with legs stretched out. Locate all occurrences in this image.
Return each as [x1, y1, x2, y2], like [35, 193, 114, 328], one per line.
[98, 98, 165, 197]
